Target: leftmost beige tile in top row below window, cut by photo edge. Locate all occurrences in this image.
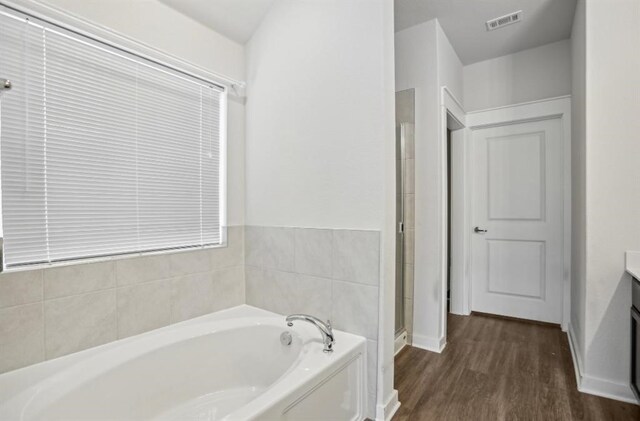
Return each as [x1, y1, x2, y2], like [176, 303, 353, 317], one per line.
[0, 270, 42, 308]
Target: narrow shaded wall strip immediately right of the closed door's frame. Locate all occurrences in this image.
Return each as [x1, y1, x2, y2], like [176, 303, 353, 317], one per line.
[570, 0, 587, 370]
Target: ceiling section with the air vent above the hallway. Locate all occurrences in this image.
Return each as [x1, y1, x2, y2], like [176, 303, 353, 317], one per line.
[395, 0, 576, 65]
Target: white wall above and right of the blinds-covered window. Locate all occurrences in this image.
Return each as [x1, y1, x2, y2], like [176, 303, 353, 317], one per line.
[22, 0, 245, 225]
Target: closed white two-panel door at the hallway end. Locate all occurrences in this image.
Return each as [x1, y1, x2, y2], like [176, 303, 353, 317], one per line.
[471, 119, 564, 323]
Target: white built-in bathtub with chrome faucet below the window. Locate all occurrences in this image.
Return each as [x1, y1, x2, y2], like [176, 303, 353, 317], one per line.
[0, 306, 366, 420]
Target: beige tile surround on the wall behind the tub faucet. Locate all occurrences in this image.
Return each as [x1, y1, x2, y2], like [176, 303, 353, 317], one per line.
[245, 226, 380, 411]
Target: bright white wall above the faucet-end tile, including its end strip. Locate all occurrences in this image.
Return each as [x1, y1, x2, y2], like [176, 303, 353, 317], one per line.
[246, 0, 395, 417]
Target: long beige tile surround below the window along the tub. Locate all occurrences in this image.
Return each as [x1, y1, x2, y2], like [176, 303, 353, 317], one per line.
[0, 227, 245, 373]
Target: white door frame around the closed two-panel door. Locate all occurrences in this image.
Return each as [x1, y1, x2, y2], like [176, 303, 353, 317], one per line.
[460, 95, 571, 335]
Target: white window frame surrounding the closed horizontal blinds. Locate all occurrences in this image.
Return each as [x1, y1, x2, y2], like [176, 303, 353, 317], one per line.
[0, 0, 230, 273]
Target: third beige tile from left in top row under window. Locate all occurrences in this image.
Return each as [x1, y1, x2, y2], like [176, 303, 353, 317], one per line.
[116, 254, 171, 286]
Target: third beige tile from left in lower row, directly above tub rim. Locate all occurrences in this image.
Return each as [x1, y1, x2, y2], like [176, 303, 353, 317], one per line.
[118, 280, 172, 338]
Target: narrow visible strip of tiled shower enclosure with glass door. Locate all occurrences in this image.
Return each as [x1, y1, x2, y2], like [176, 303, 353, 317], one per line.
[395, 89, 415, 343]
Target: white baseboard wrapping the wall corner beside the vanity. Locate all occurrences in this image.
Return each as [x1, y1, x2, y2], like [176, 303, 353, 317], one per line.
[567, 323, 638, 405]
